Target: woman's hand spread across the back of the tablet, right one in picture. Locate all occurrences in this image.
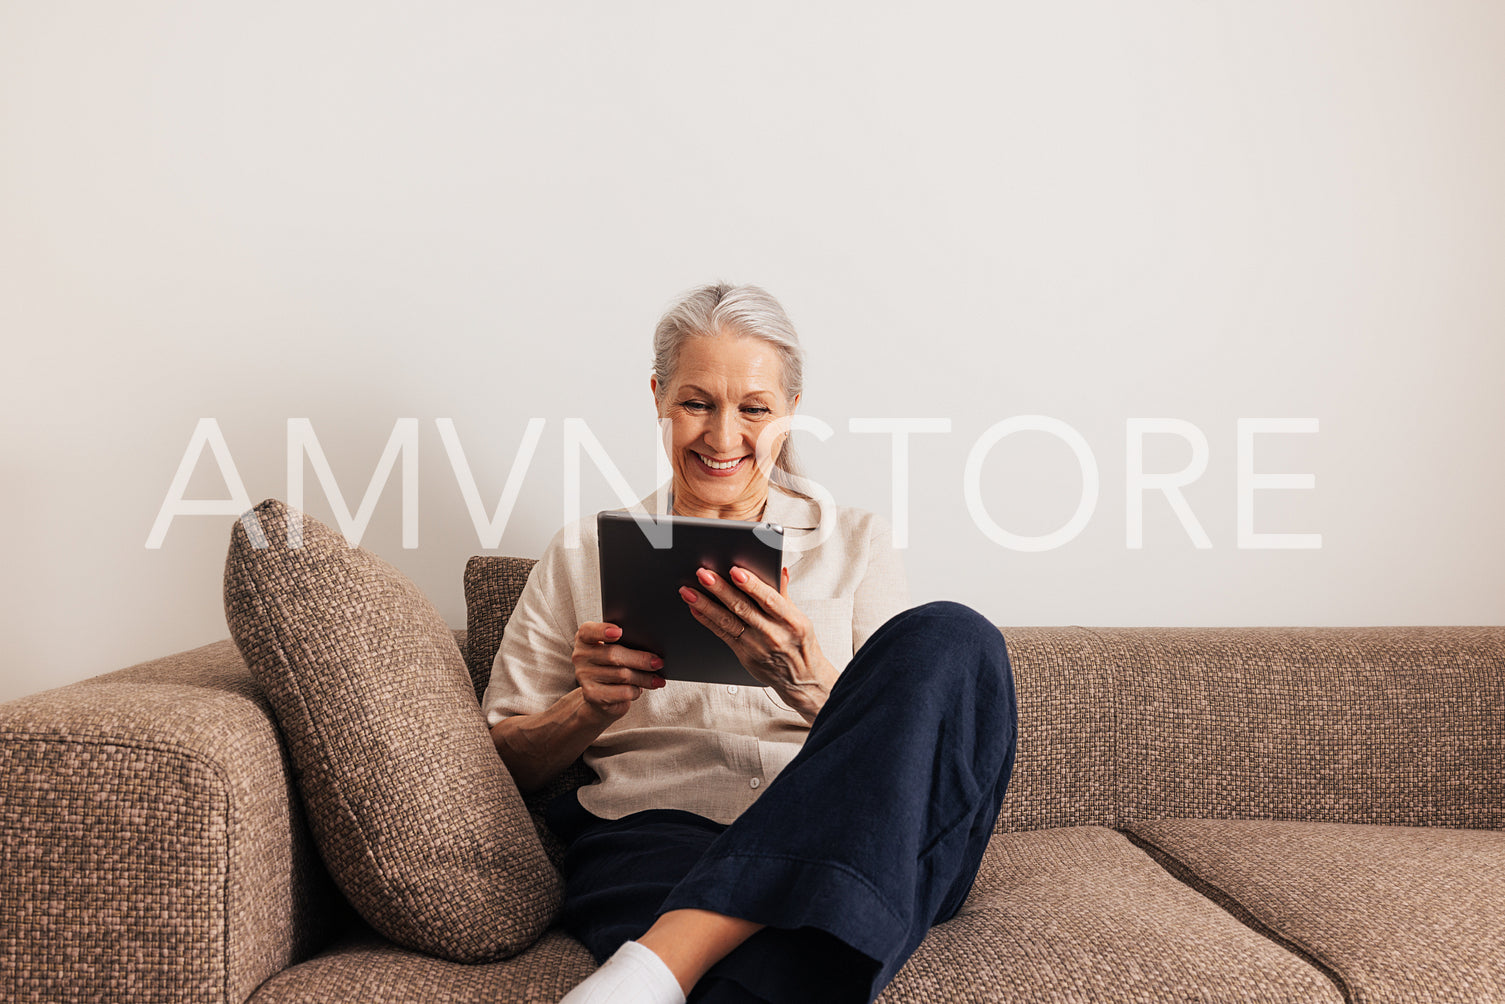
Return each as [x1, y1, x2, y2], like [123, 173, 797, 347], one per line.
[679, 566, 837, 723]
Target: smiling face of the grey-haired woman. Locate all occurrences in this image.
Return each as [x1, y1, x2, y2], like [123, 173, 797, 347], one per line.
[649, 336, 799, 519]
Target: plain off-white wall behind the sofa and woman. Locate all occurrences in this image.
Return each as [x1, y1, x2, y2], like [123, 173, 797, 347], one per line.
[0, 0, 1505, 707]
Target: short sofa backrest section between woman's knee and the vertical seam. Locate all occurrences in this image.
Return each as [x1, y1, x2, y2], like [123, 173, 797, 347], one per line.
[996, 628, 1115, 832]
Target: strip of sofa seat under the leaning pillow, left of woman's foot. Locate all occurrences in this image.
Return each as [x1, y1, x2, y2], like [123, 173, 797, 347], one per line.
[250, 929, 596, 1004]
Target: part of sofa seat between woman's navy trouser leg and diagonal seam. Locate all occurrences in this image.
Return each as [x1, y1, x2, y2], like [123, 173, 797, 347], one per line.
[879, 826, 1342, 1004]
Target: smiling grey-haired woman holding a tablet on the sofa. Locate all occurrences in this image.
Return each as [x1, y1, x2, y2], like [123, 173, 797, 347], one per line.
[485, 284, 1016, 1004]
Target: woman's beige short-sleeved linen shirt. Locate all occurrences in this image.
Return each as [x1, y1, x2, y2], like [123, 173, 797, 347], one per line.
[482, 486, 909, 823]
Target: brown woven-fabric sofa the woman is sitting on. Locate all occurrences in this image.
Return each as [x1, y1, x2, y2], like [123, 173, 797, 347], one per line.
[0, 558, 1505, 1004]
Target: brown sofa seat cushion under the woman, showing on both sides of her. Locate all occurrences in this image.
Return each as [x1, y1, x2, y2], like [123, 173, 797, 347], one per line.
[243, 826, 1342, 1004]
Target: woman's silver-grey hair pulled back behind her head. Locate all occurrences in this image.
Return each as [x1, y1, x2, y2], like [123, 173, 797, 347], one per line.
[653, 281, 805, 495]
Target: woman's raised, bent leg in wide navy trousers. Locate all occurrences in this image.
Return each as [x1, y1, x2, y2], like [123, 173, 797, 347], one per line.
[646, 602, 1017, 1001]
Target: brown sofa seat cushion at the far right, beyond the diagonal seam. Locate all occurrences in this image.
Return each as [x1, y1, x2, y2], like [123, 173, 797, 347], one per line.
[1130, 820, 1505, 1004]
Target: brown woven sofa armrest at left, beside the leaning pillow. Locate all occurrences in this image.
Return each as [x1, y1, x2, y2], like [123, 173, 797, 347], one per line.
[0, 641, 346, 1004]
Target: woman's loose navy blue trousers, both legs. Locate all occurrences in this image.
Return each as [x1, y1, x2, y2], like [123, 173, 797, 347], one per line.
[549, 602, 1017, 1004]
